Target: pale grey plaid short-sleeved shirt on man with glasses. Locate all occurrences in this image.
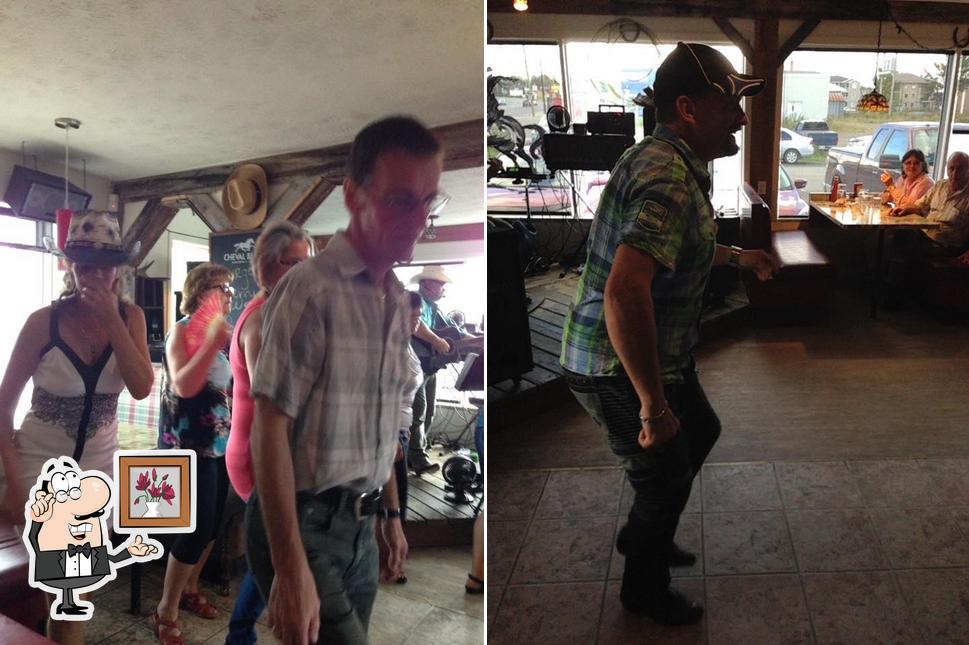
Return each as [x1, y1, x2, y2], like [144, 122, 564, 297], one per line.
[252, 231, 411, 493]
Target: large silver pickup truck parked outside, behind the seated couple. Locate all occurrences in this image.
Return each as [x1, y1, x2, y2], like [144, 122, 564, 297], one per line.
[824, 121, 969, 193]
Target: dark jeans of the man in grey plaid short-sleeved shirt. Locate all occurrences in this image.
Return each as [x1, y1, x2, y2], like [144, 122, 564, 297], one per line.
[246, 492, 380, 645]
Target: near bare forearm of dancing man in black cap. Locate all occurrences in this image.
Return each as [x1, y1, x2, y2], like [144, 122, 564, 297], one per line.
[604, 281, 666, 416]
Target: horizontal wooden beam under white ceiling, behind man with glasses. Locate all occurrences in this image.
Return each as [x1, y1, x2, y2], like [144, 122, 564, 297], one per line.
[113, 119, 485, 202]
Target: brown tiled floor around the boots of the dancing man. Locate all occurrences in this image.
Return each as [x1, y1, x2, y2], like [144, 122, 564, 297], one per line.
[488, 458, 969, 645]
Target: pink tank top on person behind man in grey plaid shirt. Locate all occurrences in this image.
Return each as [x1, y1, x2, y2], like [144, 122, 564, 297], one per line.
[225, 296, 266, 500]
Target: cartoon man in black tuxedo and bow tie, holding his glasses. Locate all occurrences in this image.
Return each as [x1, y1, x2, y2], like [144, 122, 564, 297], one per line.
[24, 457, 161, 620]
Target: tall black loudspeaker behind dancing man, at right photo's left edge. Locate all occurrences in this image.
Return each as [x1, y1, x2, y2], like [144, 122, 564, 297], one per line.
[487, 226, 534, 385]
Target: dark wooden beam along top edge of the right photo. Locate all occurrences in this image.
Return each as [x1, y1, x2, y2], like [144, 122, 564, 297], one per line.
[488, 0, 969, 24]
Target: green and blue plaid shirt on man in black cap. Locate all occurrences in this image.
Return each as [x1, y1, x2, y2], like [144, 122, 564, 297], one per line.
[560, 124, 717, 383]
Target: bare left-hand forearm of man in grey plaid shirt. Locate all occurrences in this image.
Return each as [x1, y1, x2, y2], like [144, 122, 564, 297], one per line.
[250, 397, 306, 570]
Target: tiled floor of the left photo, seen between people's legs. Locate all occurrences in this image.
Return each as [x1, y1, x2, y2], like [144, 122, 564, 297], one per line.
[85, 547, 484, 645]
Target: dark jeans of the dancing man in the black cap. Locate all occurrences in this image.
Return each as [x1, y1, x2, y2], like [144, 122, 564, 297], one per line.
[565, 367, 720, 596]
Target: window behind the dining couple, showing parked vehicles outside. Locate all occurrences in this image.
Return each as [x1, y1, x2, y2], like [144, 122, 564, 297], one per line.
[778, 50, 944, 217]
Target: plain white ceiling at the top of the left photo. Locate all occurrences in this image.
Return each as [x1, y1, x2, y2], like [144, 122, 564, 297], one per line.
[0, 0, 484, 233]
